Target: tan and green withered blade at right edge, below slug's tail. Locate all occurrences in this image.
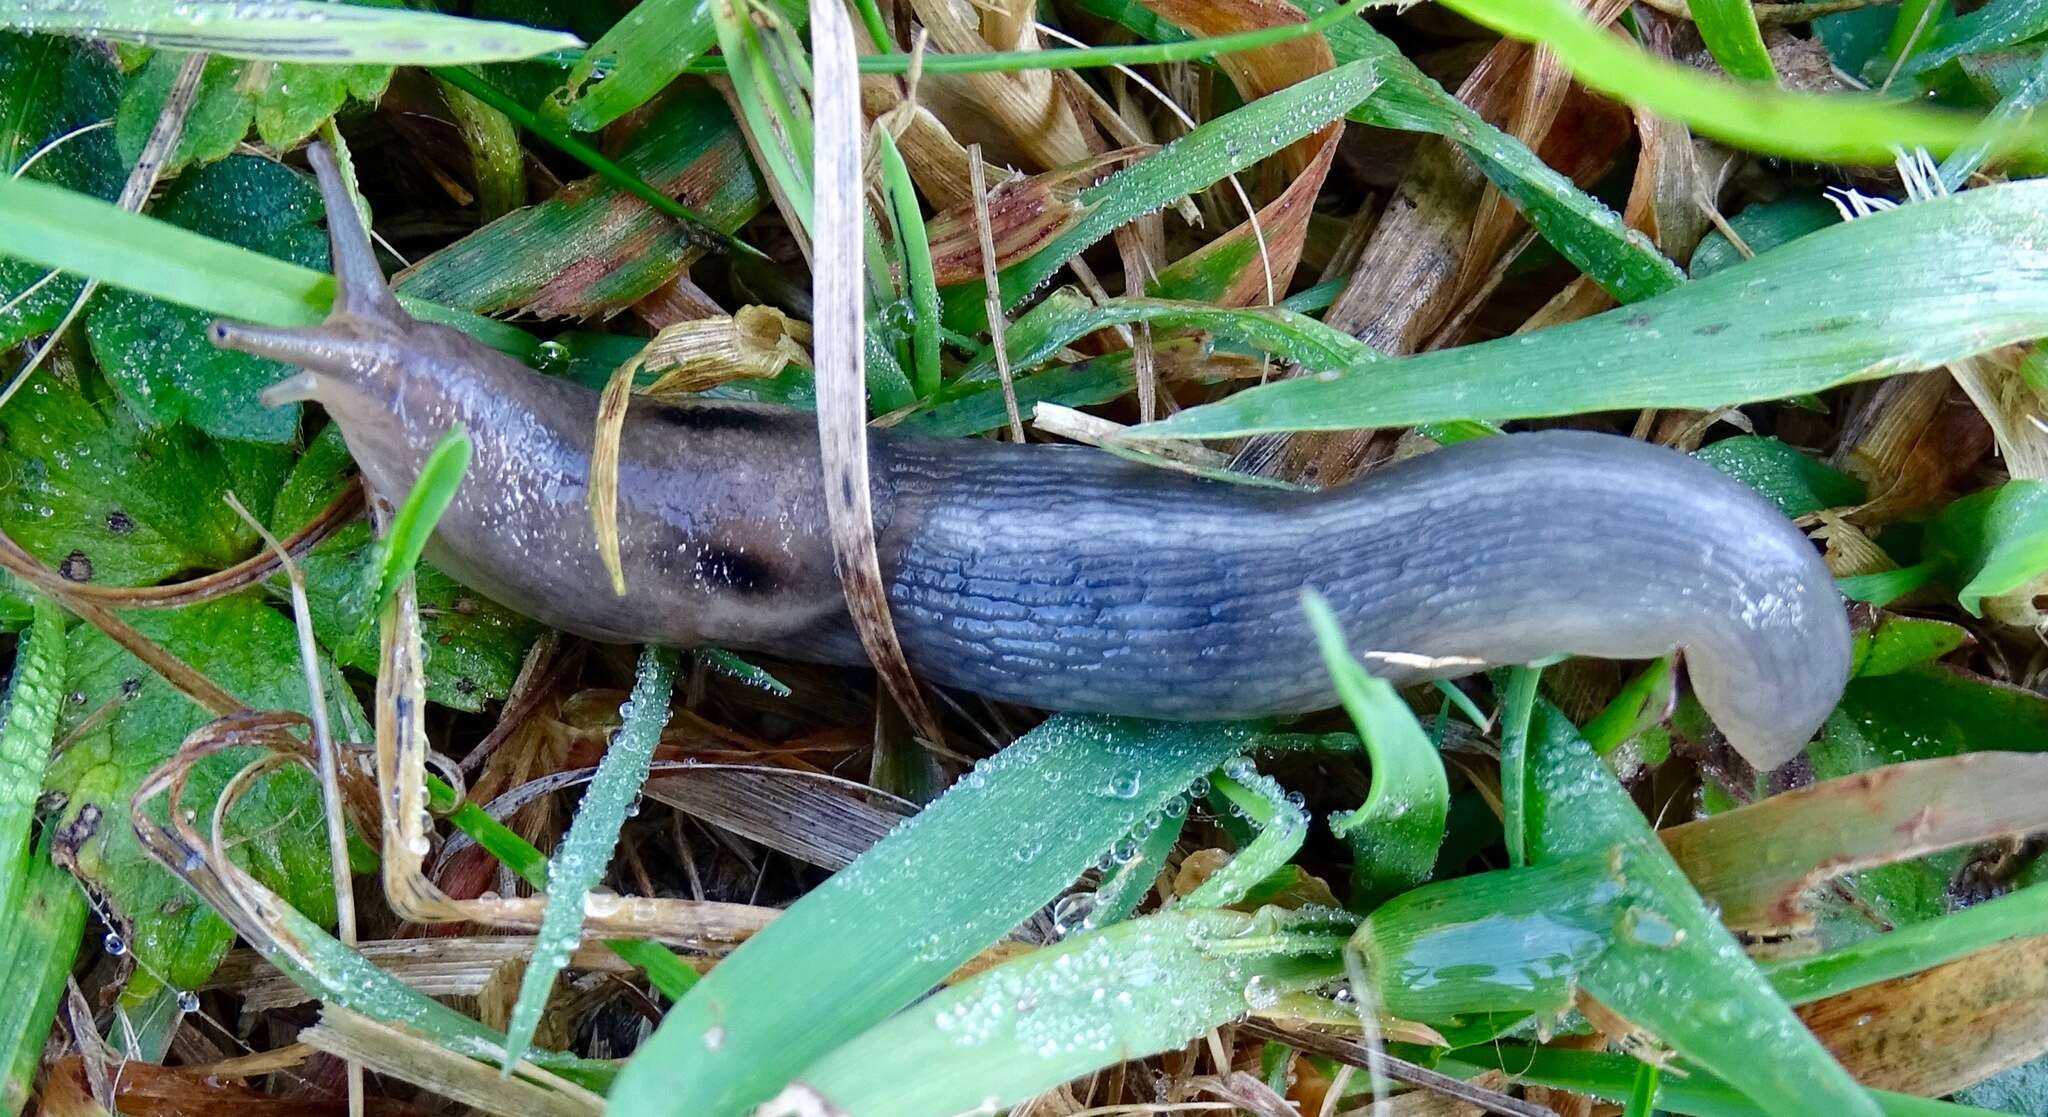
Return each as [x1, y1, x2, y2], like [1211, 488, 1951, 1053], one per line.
[1657, 752, 2048, 930]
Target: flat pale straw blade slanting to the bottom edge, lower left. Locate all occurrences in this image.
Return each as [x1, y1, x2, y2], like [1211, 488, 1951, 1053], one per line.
[299, 1004, 604, 1117]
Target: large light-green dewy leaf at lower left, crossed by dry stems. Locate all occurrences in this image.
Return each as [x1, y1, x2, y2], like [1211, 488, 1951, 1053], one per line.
[47, 594, 369, 988]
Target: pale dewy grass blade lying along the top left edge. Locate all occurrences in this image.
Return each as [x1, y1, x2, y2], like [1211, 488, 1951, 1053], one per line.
[0, 0, 584, 66]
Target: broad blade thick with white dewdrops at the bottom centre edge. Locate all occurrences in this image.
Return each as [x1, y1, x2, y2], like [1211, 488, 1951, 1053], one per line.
[793, 908, 1341, 1117]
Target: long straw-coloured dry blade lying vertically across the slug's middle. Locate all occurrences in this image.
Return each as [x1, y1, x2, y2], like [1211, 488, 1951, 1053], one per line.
[811, 4, 944, 744]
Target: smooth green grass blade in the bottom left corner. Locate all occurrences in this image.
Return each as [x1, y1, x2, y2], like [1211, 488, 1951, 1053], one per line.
[0, 840, 86, 1115]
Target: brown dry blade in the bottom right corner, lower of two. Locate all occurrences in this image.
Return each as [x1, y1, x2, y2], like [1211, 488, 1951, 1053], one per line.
[1798, 939, 2048, 1097]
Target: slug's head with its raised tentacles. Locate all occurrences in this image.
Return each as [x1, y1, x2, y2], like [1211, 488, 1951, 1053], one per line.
[207, 143, 434, 428]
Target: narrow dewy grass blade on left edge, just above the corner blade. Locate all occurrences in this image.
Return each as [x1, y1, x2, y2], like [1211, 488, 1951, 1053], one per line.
[0, 596, 63, 914]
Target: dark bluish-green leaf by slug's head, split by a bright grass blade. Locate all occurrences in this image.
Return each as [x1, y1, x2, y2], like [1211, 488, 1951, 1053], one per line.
[86, 156, 328, 443]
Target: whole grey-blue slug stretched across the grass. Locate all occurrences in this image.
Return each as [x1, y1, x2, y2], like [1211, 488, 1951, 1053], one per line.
[213, 148, 1849, 769]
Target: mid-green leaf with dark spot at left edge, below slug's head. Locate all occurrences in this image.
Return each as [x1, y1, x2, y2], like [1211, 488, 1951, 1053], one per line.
[0, 371, 289, 586]
